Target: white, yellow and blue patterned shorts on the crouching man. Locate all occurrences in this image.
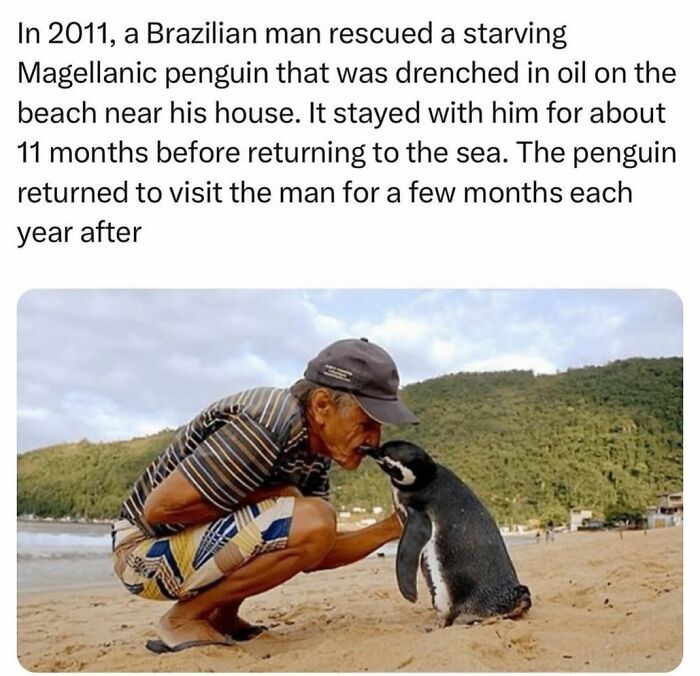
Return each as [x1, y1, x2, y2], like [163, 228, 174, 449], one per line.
[112, 497, 294, 601]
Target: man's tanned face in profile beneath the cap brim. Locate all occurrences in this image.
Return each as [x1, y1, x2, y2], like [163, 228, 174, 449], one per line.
[319, 403, 382, 469]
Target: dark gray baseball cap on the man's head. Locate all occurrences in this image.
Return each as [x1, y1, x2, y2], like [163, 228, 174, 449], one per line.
[304, 338, 418, 424]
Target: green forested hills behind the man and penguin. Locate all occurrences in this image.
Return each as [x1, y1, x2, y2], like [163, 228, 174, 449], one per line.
[17, 358, 683, 523]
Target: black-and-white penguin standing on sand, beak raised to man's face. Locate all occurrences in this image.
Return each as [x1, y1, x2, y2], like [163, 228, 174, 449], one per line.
[366, 441, 532, 627]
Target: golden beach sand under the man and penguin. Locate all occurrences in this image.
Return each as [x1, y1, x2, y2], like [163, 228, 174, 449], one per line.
[18, 528, 683, 672]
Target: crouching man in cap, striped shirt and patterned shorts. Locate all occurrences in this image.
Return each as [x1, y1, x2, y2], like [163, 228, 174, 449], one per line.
[113, 338, 418, 652]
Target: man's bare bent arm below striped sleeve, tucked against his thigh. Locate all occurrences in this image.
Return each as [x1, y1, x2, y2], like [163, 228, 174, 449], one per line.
[143, 469, 301, 526]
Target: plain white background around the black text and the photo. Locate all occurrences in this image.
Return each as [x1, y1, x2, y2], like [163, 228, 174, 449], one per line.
[0, 0, 699, 672]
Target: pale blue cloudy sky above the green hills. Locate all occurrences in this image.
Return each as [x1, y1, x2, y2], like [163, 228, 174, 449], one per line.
[17, 290, 683, 452]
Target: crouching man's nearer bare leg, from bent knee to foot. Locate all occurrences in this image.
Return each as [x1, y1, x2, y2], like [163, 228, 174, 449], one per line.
[158, 498, 336, 647]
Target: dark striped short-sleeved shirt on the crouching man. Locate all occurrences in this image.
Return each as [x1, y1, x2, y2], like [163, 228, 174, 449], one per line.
[121, 387, 330, 535]
